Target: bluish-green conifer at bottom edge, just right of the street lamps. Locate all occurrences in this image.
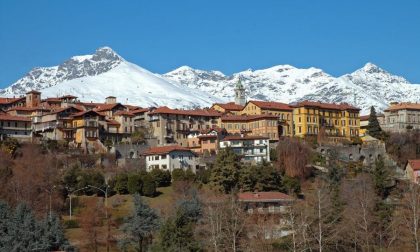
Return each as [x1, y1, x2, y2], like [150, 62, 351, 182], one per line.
[120, 194, 159, 252]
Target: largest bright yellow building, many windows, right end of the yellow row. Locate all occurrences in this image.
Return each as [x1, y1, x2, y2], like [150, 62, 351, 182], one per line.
[293, 101, 360, 140]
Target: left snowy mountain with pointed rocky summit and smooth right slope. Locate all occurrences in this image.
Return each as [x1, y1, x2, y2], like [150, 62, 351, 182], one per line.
[0, 47, 222, 108]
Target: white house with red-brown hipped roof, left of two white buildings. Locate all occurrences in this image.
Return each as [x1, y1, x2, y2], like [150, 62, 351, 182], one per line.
[144, 145, 198, 173]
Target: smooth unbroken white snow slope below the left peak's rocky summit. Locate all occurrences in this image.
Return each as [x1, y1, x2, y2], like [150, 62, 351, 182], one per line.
[42, 61, 222, 108]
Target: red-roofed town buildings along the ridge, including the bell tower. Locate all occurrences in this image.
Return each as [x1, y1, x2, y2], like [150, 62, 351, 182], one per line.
[0, 80, 420, 176]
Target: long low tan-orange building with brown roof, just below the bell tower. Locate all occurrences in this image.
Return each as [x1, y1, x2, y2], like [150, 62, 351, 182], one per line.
[219, 115, 281, 141]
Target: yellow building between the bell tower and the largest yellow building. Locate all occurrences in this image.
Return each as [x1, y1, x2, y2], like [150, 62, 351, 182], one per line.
[239, 101, 293, 136]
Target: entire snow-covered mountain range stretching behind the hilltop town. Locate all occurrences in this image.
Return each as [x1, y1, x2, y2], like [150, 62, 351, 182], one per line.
[0, 47, 420, 114]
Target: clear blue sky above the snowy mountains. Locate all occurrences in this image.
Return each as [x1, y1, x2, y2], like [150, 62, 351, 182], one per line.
[0, 0, 420, 88]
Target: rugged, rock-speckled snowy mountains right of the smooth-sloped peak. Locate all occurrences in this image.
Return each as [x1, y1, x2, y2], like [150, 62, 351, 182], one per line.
[163, 63, 420, 114]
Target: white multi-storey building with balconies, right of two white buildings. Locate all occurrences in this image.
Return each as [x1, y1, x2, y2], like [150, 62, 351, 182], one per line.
[220, 135, 270, 163]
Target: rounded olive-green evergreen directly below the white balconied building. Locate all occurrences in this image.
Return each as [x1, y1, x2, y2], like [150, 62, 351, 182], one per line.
[210, 148, 241, 193]
